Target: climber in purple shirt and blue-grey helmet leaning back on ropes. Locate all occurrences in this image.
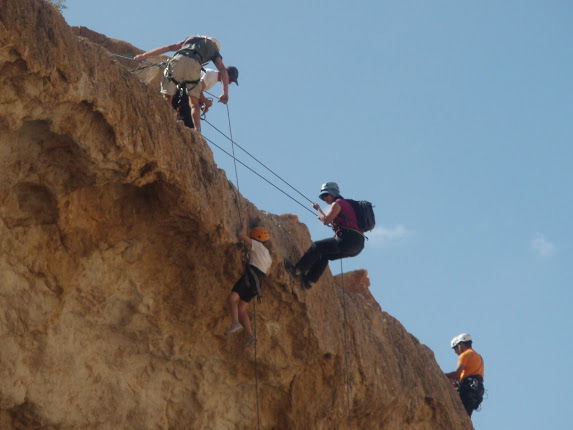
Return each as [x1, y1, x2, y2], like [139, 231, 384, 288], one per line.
[285, 182, 364, 290]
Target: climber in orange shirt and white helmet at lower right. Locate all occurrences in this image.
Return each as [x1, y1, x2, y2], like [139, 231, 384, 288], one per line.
[446, 333, 484, 417]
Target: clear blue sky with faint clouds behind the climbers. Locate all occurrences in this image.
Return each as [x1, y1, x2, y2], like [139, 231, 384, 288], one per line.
[60, 0, 573, 430]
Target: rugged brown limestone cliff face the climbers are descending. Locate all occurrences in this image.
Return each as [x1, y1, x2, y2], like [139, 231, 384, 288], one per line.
[0, 0, 471, 430]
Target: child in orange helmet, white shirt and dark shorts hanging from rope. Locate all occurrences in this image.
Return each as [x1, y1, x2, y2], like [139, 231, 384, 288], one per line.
[225, 227, 272, 348]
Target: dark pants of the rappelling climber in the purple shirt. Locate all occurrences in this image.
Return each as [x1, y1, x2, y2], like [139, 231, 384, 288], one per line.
[295, 229, 364, 282]
